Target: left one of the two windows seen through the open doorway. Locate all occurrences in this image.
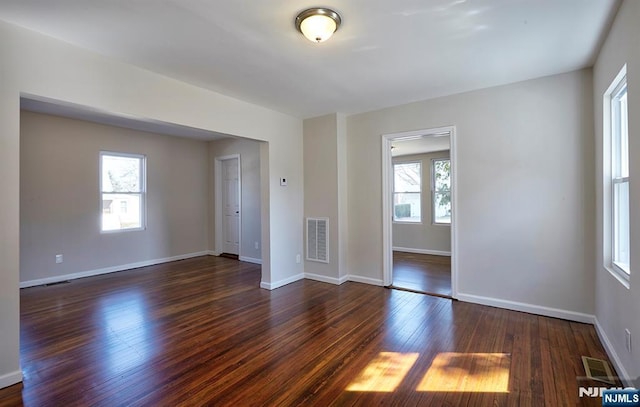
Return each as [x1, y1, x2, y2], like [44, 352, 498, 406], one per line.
[393, 162, 422, 223]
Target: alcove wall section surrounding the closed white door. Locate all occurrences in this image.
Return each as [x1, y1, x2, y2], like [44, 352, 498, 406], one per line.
[209, 138, 262, 262]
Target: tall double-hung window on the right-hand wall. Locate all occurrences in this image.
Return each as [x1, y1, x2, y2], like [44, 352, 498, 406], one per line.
[603, 66, 631, 280]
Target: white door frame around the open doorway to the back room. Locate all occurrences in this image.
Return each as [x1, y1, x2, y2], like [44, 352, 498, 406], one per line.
[382, 126, 458, 298]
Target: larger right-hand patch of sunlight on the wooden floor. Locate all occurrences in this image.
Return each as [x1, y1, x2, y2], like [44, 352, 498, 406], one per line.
[417, 353, 511, 393]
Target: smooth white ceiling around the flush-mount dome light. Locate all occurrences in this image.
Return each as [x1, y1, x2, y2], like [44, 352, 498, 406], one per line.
[0, 0, 618, 118]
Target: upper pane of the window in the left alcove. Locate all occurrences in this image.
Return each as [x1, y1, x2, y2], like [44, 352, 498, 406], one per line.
[102, 155, 142, 192]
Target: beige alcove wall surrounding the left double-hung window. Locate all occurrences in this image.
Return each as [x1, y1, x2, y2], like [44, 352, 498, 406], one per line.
[20, 111, 208, 282]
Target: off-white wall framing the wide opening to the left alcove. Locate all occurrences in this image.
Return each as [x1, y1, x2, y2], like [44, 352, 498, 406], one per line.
[0, 23, 303, 387]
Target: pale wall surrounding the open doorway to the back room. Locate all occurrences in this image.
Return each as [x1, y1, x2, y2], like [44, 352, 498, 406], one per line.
[347, 69, 595, 320]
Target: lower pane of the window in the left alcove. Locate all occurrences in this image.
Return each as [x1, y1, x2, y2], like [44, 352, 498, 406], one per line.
[102, 194, 142, 231]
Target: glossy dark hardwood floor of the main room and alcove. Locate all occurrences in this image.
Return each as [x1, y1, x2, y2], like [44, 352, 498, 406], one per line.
[0, 257, 620, 406]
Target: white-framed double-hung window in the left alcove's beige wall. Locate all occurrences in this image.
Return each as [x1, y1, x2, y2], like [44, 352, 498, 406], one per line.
[100, 152, 145, 232]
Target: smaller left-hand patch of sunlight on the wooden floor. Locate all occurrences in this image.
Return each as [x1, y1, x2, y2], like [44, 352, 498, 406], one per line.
[347, 352, 419, 392]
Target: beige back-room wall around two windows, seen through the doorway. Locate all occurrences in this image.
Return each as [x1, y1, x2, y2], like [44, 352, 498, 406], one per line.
[393, 151, 451, 254]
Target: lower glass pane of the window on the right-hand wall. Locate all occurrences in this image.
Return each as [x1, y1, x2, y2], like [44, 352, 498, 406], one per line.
[613, 182, 630, 272]
